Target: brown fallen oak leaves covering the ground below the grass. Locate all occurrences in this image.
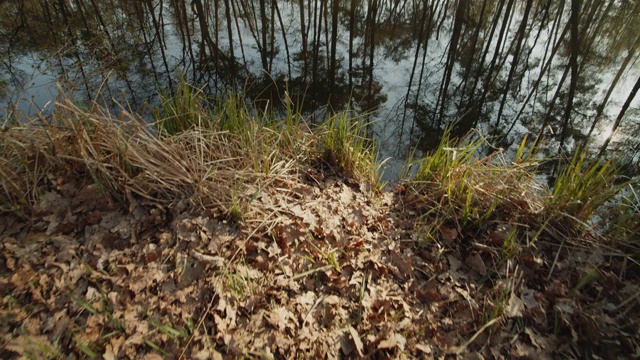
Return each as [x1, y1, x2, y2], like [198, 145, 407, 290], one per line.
[0, 169, 639, 359]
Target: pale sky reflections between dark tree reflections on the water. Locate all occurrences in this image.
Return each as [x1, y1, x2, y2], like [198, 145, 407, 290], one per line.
[0, 2, 640, 173]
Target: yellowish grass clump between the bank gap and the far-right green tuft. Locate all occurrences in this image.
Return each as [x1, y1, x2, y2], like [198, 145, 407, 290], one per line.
[409, 129, 542, 227]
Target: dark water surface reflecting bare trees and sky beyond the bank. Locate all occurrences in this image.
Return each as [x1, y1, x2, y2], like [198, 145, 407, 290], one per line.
[0, 0, 640, 179]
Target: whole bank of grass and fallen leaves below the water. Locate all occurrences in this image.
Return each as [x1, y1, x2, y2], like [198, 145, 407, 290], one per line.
[0, 90, 640, 358]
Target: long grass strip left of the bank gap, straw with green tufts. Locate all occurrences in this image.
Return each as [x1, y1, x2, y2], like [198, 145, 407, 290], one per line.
[0, 84, 378, 219]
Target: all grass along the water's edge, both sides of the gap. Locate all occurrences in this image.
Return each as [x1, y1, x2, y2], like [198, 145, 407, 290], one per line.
[0, 82, 637, 248]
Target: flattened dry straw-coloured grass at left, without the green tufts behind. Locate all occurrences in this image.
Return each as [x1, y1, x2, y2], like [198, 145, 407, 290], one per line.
[0, 101, 292, 217]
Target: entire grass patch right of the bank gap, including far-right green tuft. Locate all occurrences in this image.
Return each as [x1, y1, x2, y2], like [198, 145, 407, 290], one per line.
[404, 129, 637, 253]
